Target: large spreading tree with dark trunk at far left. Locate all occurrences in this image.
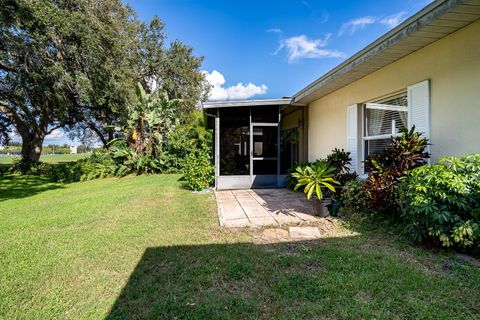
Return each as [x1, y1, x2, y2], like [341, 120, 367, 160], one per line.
[0, 0, 136, 161]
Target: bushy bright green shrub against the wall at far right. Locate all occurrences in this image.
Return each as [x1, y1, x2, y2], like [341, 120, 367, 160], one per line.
[398, 155, 480, 250]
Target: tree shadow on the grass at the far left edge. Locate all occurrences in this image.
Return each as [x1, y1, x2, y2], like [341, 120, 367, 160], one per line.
[0, 173, 63, 202]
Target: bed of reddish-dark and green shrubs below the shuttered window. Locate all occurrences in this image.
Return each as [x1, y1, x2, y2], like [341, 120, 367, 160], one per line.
[340, 128, 480, 253]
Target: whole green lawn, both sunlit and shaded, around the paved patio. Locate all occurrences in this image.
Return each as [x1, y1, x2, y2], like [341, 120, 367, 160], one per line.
[0, 175, 480, 319]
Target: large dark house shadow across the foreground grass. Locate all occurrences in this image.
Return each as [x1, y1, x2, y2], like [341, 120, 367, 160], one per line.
[106, 235, 479, 320]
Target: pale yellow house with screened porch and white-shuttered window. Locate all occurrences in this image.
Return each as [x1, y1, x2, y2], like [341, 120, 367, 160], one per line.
[204, 0, 480, 189]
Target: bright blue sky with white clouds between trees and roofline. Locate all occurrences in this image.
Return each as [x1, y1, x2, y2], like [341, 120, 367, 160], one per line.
[38, 0, 431, 144]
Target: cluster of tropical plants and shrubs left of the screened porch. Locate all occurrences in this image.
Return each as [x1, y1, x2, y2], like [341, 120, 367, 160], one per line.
[76, 89, 214, 185]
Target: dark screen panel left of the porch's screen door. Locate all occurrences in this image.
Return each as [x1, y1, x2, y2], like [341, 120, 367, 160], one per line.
[220, 107, 250, 176]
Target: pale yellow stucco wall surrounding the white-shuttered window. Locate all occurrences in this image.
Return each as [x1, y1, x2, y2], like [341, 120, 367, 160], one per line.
[308, 21, 480, 161]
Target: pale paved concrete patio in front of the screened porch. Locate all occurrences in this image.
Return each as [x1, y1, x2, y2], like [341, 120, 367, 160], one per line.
[215, 189, 318, 228]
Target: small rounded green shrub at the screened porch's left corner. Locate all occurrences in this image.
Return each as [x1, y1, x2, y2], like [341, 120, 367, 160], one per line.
[181, 149, 215, 191]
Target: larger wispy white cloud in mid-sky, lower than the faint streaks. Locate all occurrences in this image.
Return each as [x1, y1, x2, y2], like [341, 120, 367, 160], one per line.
[274, 34, 345, 63]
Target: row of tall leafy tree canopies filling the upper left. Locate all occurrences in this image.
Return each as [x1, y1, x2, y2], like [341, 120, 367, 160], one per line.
[0, 0, 210, 162]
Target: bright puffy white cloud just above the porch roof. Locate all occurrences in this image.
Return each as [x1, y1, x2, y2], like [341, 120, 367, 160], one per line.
[203, 70, 268, 101]
